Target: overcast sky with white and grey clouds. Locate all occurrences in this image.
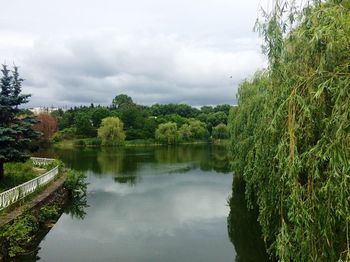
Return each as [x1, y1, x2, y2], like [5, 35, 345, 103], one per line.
[0, 0, 269, 106]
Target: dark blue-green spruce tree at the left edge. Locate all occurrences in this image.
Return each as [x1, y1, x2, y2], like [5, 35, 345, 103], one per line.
[0, 65, 38, 180]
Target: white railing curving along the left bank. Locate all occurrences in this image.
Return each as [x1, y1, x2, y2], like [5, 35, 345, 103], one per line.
[0, 157, 58, 210]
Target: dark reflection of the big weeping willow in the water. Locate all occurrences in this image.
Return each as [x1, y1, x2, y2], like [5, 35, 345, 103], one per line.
[227, 176, 270, 262]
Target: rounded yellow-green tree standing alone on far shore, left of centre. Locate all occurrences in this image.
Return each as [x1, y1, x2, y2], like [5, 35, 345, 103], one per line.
[97, 117, 125, 145]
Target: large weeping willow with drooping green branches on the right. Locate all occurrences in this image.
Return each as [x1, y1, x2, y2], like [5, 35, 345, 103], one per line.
[230, 0, 350, 261]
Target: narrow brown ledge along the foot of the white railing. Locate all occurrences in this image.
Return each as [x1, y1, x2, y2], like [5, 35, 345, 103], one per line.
[0, 175, 66, 228]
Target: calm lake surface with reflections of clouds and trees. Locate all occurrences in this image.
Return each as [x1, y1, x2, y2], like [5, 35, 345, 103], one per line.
[26, 145, 266, 262]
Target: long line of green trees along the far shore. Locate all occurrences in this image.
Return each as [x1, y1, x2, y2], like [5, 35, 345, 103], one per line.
[47, 94, 231, 144]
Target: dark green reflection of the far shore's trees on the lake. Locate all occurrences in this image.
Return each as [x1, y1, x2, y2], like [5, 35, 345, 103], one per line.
[41, 145, 230, 185]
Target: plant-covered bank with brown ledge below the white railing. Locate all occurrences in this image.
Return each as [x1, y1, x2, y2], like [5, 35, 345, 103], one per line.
[0, 174, 69, 261]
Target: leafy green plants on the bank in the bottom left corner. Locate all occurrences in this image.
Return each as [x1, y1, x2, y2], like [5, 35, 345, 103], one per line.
[0, 214, 39, 257]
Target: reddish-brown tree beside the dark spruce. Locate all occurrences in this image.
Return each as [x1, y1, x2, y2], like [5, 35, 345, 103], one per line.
[33, 113, 57, 142]
